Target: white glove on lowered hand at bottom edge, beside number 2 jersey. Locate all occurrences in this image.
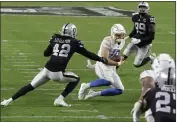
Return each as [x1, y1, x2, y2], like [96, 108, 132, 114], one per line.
[131, 101, 142, 122]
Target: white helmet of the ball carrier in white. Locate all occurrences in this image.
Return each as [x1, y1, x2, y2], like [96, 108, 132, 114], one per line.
[111, 24, 126, 43]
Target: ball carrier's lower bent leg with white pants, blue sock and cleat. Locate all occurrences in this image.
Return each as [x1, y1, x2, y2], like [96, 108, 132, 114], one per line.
[85, 72, 124, 99]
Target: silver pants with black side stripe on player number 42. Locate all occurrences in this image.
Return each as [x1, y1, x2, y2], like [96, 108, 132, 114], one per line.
[31, 68, 79, 88]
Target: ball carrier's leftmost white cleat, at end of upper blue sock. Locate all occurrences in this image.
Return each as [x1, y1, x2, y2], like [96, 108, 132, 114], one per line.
[78, 83, 88, 100]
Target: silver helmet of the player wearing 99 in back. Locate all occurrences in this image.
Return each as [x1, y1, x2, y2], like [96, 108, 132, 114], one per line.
[137, 2, 150, 14]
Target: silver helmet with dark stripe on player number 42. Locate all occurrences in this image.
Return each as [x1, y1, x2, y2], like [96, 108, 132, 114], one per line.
[61, 23, 77, 38]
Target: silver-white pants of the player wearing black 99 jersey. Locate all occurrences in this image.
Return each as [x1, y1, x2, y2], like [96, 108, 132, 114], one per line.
[123, 43, 152, 66]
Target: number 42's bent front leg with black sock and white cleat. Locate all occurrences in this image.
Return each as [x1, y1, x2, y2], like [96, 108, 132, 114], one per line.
[54, 72, 80, 107]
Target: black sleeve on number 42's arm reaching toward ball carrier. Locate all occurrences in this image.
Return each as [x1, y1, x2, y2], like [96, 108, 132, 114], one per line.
[76, 41, 100, 61]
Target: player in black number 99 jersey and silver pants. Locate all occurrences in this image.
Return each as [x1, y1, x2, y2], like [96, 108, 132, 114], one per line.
[123, 2, 155, 67]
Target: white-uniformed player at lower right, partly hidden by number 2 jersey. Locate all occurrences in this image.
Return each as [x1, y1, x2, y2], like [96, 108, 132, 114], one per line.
[131, 54, 175, 122]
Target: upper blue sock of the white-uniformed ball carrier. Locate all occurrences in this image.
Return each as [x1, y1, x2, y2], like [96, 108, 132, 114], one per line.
[90, 79, 111, 87]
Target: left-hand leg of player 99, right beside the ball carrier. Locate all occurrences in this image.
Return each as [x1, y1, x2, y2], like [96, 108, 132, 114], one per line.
[123, 43, 137, 60]
